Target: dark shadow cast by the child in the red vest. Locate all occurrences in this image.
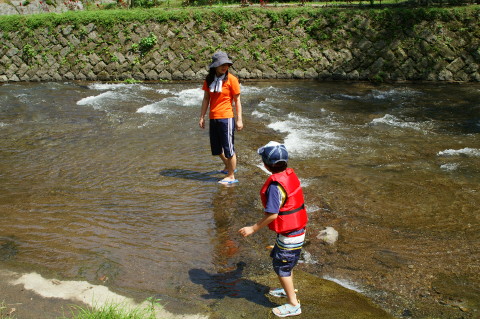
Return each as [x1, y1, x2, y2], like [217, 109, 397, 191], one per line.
[188, 262, 275, 307]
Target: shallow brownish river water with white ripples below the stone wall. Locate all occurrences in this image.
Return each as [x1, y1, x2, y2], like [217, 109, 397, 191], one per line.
[0, 81, 480, 314]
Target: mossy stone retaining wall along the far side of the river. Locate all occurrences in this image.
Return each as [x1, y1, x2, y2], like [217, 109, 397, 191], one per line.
[0, 9, 480, 82]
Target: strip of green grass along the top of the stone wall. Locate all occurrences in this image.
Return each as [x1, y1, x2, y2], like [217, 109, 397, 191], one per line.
[0, 6, 480, 33]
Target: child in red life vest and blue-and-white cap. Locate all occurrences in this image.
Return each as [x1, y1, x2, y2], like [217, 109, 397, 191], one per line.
[238, 142, 308, 317]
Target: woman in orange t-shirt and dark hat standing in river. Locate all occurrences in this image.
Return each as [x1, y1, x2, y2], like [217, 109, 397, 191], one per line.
[198, 51, 243, 184]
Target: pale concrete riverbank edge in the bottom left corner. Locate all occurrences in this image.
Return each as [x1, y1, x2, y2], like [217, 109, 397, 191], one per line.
[0, 268, 208, 319]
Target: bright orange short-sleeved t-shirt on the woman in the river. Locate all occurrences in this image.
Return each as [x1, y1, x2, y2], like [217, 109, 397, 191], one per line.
[202, 74, 240, 119]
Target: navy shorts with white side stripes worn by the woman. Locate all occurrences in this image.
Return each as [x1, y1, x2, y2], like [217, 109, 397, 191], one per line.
[209, 117, 235, 158]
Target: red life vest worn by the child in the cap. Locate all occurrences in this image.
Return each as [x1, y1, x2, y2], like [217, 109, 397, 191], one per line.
[260, 168, 308, 234]
